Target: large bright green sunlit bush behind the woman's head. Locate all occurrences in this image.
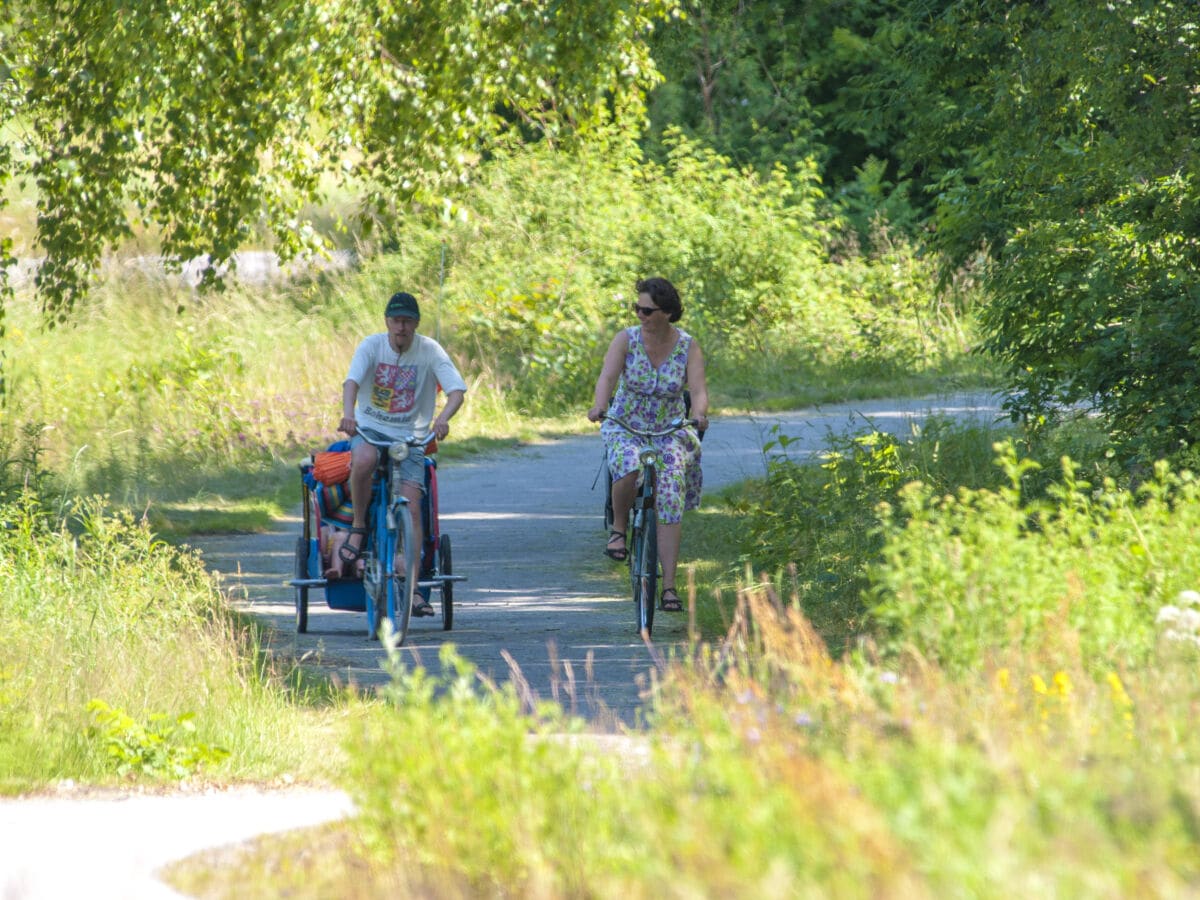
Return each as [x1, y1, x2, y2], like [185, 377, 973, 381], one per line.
[422, 134, 970, 412]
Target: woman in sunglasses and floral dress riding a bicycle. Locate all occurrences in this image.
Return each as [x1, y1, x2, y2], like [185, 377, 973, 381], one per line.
[588, 278, 708, 612]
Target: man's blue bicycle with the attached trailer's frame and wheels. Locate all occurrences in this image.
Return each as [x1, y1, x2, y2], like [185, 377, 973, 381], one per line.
[292, 434, 466, 644]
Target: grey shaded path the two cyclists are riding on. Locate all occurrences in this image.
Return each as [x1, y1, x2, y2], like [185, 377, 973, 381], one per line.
[202, 395, 996, 730]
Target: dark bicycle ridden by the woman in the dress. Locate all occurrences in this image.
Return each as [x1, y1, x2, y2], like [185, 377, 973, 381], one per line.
[604, 415, 700, 637]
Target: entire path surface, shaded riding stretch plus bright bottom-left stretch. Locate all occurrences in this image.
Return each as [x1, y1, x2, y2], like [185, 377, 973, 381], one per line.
[0, 395, 997, 900]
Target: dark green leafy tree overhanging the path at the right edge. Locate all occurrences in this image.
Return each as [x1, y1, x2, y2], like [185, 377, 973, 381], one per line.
[864, 0, 1200, 465]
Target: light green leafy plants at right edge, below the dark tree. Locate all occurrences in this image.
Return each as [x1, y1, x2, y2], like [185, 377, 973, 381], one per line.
[870, 444, 1200, 672]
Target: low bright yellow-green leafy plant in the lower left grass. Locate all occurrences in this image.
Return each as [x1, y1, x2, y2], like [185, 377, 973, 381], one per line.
[88, 700, 229, 780]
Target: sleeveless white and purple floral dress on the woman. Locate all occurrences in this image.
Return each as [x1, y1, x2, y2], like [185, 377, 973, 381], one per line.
[600, 326, 702, 524]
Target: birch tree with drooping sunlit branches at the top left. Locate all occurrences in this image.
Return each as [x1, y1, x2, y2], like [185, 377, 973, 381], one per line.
[0, 0, 674, 320]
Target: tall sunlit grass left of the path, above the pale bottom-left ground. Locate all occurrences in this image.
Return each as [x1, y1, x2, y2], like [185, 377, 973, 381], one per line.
[0, 493, 343, 791]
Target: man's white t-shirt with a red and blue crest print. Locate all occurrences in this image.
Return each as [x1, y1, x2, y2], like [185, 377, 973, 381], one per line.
[346, 332, 467, 438]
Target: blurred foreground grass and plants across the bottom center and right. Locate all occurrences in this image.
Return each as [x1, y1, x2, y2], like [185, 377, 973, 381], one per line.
[246, 583, 1200, 898]
